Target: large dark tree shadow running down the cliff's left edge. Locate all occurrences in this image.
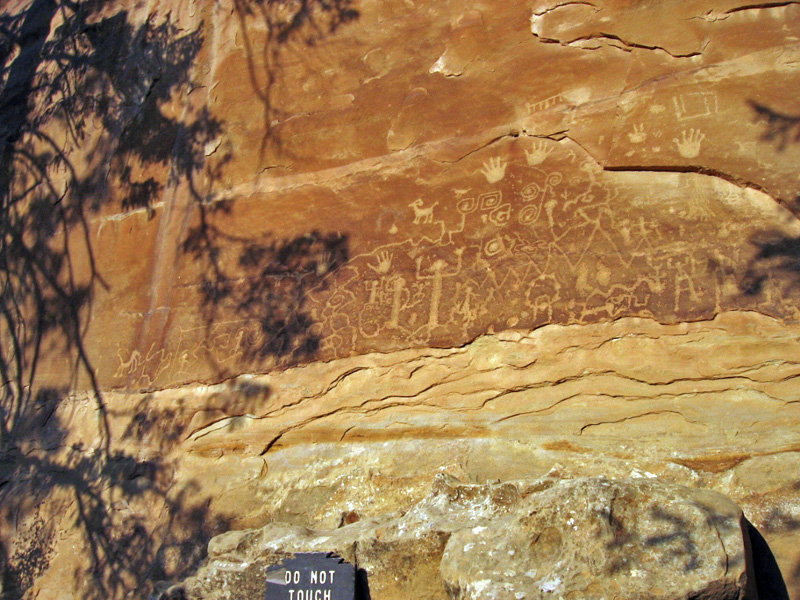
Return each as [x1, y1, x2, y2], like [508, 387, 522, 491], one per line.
[0, 0, 228, 599]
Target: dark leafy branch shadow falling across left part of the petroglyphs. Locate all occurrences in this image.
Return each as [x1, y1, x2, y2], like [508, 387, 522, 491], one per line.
[183, 206, 349, 375]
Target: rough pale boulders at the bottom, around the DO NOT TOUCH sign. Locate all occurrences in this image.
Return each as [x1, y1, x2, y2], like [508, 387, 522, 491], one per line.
[175, 475, 756, 600]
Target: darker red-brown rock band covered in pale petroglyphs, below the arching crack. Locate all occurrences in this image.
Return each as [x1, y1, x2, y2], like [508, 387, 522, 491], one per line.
[98, 134, 800, 388]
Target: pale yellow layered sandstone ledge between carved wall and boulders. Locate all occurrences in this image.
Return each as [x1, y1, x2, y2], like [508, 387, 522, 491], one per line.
[9, 313, 800, 598]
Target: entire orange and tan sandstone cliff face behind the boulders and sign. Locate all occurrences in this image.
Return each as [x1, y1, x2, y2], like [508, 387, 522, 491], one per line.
[0, 0, 800, 599]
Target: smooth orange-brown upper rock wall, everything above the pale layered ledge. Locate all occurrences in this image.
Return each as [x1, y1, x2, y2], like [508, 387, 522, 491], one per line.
[0, 0, 800, 389]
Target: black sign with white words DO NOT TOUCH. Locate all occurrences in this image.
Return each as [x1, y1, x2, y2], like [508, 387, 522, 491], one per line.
[265, 552, 356, 600]
